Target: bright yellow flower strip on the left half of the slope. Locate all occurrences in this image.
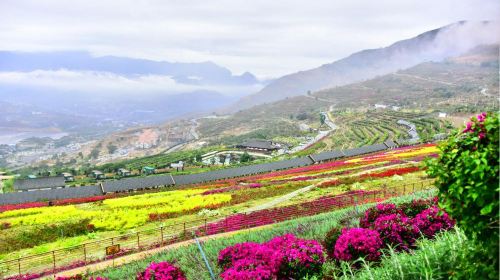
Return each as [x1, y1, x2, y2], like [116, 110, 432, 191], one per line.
[0, 190, 231, 230]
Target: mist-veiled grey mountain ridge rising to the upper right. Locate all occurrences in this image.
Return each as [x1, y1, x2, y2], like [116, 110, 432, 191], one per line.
[235, 21, 500, 110]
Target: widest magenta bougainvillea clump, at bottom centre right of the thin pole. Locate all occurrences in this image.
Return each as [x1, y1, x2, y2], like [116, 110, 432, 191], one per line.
[218, 234, 325, 280]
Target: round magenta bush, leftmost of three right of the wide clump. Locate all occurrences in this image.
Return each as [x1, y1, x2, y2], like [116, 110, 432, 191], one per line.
[334, 228, 383, 261]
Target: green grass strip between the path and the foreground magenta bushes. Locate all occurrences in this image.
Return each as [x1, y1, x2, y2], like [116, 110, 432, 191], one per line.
[89, 189, 433, 279]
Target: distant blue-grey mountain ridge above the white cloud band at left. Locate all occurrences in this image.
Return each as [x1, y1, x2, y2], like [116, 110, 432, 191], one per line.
[0, 51, 258, 85]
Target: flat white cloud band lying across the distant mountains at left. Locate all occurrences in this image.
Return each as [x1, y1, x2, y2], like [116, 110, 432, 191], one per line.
[0, 70, 261, 95]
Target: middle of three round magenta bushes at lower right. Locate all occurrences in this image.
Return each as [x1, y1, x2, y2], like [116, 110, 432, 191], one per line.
[373, 214, 419, 251]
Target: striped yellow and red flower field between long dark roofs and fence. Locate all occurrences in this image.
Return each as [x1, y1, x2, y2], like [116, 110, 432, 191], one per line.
[0, 145, 436, 278]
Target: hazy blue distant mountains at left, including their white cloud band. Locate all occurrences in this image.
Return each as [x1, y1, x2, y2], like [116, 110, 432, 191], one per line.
[0, 51, 262, 135]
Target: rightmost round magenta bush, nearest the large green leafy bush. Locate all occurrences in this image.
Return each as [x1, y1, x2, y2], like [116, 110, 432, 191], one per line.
[413, 206, 455, 238]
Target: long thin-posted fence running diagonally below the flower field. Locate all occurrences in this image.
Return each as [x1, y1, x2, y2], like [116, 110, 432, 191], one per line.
[0, 180, 433, 280]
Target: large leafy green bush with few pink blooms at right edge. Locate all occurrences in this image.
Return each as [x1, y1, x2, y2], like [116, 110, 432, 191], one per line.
[428, 113, 499, 278]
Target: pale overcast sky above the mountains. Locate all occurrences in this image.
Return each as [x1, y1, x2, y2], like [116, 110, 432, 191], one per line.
[0, 0, 500, 79]
